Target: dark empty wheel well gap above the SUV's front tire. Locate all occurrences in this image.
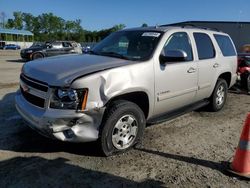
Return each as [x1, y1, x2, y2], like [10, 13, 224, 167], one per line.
[105, 91, 149, 119]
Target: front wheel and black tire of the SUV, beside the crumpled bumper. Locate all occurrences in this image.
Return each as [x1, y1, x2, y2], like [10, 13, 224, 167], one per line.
[100, 100, 146, 156]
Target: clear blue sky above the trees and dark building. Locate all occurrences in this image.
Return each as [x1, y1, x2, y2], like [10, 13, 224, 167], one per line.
[0, 0, 250, 31]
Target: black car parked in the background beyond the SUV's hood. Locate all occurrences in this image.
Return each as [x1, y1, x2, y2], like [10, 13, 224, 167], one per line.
[20, 41, 82, 60]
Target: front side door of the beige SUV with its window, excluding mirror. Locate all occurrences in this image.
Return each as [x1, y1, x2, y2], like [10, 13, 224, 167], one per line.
[155, 32, 197, 114]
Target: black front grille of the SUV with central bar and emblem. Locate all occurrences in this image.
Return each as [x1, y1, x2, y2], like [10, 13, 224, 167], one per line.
[20, 74, 48, 108]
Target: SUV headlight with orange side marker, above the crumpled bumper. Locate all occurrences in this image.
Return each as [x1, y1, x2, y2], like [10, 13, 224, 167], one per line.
[50, 89, 88, 111]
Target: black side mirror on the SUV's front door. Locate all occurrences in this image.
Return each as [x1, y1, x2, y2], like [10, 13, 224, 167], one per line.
[160, 50, 187, 64]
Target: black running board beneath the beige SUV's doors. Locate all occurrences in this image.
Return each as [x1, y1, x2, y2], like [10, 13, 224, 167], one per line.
[147, 100, 209, 125]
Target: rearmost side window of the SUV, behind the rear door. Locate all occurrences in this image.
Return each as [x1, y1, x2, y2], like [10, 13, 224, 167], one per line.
[214, 34, 236, 56]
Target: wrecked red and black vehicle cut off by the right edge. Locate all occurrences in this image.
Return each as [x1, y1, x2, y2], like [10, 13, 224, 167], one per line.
[238, 53, 250, 94]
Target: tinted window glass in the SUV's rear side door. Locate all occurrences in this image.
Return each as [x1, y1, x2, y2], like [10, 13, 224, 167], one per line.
[194, 33, 215, 59]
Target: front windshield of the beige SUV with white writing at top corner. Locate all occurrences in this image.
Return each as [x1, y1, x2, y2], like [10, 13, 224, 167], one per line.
[91, 31, 162, 61]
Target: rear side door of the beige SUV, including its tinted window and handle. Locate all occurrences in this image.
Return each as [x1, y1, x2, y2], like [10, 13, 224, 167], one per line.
[193, 32, 220, 101]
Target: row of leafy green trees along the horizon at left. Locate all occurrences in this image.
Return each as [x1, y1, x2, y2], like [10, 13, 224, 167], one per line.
[2, 11, 125, 42]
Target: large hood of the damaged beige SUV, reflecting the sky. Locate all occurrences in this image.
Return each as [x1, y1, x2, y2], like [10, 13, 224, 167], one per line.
[22, 54, 136, 87]
